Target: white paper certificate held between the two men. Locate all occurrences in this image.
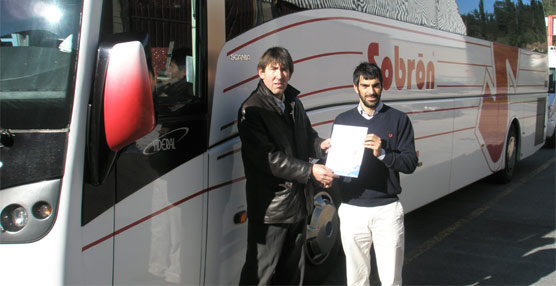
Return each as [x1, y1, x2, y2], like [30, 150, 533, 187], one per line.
[326, 124, 367, 178]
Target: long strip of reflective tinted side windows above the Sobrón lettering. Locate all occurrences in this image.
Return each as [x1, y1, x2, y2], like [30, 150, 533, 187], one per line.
[226, 0, 546, 52]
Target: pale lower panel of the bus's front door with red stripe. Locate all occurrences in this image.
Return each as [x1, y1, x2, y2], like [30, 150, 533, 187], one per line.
[108, 154, 207, 285]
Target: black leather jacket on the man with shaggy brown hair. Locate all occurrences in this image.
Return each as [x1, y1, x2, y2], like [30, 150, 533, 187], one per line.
[238, 81, 323, 224]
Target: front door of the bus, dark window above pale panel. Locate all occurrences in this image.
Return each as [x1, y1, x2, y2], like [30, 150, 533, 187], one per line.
[94, 0, 207, 285]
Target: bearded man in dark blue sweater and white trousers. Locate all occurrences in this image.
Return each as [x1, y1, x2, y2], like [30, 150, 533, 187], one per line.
[334, 62, 417, 286]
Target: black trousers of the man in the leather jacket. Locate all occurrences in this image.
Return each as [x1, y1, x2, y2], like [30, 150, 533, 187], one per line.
[239, 220, 307, 285]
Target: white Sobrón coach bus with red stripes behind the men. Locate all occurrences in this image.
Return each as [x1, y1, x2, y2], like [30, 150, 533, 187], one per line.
[0, 0, 548, 285]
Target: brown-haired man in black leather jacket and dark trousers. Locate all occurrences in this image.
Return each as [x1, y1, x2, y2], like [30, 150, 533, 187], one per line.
[238, 47, 335, 285]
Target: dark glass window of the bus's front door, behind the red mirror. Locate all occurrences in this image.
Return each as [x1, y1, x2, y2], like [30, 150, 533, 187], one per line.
[103, 0, 204, 120]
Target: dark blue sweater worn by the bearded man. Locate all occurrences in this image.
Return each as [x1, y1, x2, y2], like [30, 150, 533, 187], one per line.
[332, 105, 418, 207]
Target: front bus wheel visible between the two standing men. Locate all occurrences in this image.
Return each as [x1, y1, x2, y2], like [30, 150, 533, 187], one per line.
[304, 187, 340, 284]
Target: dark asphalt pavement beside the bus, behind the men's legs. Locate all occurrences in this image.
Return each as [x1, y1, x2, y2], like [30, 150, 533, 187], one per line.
[324, 148, 556, 285]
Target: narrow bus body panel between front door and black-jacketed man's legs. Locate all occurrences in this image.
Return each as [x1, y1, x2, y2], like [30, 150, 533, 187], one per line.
[204, 137, 247, 285]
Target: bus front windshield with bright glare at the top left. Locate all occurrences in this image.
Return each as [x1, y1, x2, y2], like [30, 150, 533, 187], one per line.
[0, 0, 82, 129]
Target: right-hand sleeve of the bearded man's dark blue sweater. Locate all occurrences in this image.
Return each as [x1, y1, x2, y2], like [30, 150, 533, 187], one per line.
[383, 114, 418, 174]
